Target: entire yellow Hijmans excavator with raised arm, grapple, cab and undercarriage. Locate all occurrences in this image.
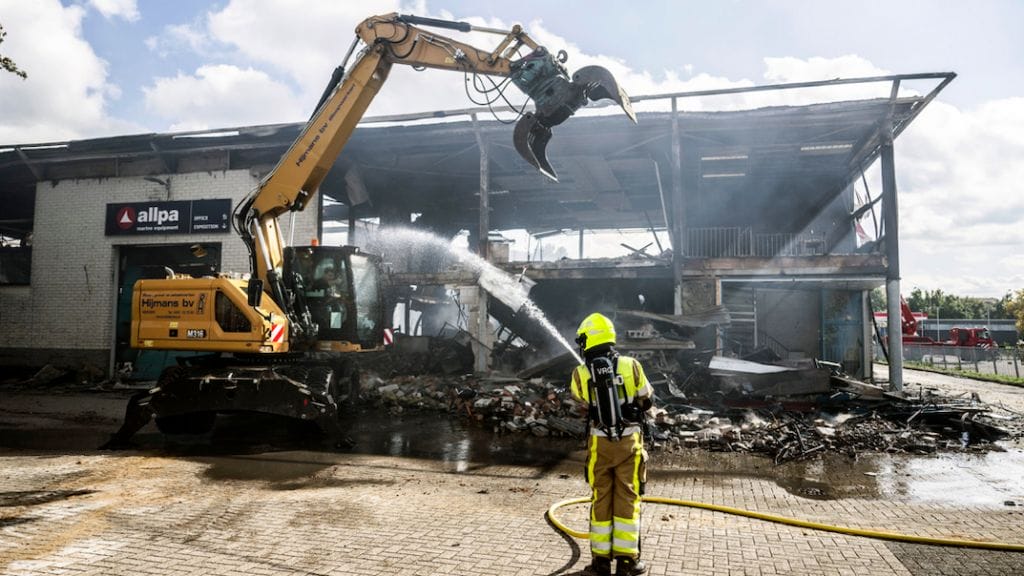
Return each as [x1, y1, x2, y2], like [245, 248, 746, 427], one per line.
[108, 13, 636, 448]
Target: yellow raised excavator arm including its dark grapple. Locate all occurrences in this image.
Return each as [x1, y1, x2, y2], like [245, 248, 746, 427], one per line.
[236, 13, 636, 339]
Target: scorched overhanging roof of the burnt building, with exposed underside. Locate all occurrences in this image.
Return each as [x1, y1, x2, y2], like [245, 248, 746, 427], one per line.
[0, 73, 955, 238]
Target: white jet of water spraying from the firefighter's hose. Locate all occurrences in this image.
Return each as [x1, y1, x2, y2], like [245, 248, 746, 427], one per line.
[368, 228, 583, 364]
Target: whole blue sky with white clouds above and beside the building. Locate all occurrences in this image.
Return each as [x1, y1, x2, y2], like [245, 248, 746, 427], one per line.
[0, 0, 1024, 297]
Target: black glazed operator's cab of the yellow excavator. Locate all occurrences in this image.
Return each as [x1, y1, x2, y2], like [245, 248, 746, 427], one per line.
[284, 246, 384, 352]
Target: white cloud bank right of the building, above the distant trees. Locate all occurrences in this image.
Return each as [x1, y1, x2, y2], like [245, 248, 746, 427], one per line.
[895, 97, 1024, 297]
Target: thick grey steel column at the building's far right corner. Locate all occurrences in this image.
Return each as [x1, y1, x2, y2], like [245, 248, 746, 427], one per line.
[881, 121, 903, 392]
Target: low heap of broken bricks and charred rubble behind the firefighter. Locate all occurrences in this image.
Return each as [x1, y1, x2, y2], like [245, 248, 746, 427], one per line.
[360, 362, 1024, 463]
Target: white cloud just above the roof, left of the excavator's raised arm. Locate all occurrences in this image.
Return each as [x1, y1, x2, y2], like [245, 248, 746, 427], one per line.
[143, 65, 302, 131]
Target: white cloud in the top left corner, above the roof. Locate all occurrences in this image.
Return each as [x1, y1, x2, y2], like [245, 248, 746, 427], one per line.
[0, 0, 135, 143]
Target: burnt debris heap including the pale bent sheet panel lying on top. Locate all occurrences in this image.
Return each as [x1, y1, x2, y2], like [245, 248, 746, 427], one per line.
[360, 340, 1024, 463]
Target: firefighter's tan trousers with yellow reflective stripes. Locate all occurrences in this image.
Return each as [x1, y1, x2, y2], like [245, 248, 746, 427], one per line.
[587, 433, 647, 559]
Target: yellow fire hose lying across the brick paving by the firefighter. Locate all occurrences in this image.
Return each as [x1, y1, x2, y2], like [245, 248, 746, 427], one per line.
[547, 496, 1024, 552]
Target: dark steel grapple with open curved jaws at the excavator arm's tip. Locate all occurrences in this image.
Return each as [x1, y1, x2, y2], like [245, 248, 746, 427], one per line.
[510, 47, 637, 181]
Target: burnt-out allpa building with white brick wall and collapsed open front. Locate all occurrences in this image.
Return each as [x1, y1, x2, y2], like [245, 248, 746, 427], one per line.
[0, 73, 954, 385]
